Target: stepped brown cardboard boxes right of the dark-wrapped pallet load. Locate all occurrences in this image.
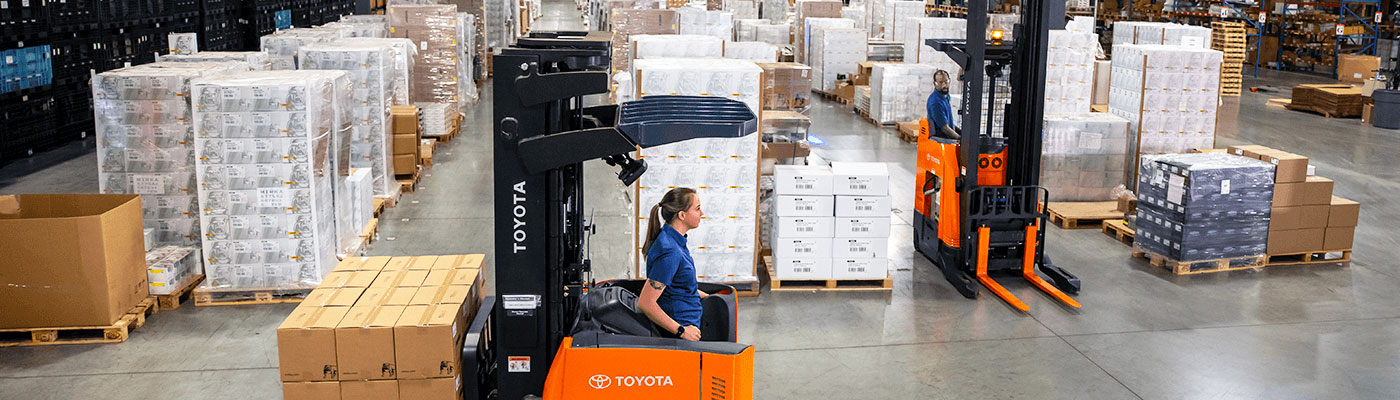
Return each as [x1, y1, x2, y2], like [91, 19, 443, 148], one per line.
[1228, 145, 1361, 255]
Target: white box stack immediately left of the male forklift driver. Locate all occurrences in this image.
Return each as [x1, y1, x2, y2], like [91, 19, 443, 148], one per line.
[869, 63, 934, 123]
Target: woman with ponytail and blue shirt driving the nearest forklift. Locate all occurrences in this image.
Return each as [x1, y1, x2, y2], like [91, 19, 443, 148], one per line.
[637, 187, 728, 341]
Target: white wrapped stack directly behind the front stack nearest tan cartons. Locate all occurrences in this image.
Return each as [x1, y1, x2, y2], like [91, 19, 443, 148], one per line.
[297, 41, 399, 197]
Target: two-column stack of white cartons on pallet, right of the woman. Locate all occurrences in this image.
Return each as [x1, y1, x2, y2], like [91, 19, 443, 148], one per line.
[771, 162, 890, 280]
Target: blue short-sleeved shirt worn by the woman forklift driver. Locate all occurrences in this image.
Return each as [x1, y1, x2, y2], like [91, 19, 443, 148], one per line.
[647, 225, 701, 327]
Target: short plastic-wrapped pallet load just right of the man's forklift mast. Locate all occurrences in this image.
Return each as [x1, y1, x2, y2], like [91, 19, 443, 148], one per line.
[1040, 112, 1128, 201]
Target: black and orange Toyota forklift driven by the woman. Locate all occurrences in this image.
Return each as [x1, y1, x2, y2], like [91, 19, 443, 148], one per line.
[462, 32, 757, 400]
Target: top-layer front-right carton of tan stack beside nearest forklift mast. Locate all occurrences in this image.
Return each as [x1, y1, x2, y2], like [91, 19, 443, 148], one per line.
[393, 305, 465, 379]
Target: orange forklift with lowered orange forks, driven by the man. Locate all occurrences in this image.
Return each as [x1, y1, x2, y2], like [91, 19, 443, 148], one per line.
[914, 0, 1079, 310]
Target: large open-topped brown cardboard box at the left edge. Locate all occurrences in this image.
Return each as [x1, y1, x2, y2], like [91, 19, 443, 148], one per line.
[0, 194, 148, 329]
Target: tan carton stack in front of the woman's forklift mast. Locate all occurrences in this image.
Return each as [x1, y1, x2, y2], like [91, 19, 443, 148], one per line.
[277, 255, 482, 400]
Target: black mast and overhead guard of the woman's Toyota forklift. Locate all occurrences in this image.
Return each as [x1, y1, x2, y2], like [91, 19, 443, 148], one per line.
[487, 32, 757, 400]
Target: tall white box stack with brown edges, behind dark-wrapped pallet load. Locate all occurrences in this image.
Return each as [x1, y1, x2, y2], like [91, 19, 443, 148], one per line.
[1109, 45, 1222, 179]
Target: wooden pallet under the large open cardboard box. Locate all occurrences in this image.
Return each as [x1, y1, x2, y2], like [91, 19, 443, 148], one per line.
[0, 298, 157, 347]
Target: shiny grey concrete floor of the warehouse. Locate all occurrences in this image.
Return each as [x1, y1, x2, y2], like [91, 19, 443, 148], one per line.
[0, 0, 1400, 400]
